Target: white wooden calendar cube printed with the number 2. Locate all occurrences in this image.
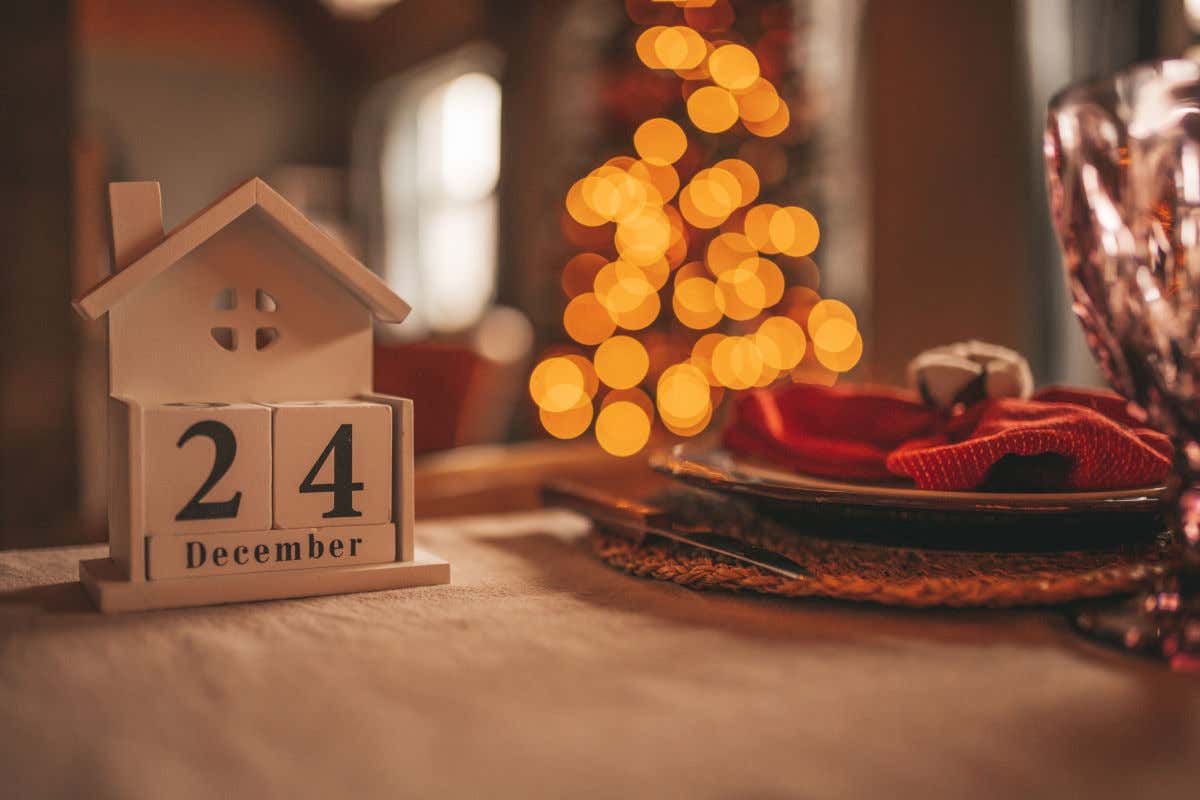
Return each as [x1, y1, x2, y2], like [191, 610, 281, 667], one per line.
[142, 403, 271, 535]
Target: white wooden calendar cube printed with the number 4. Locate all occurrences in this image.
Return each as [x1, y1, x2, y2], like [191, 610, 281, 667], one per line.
[269, 399, 394, 528]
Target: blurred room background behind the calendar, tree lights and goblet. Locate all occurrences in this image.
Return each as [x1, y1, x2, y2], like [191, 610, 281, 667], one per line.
[0, 0, 1200, 547]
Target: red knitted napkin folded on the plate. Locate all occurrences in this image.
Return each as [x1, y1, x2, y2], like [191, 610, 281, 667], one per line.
[724, 384, 1171, 491]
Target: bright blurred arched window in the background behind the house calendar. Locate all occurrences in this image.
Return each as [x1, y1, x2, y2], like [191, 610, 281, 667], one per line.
[365, 48, 502, 336]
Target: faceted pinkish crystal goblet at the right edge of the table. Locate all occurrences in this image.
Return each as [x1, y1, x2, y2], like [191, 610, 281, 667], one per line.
[1045, 61, 1200, 669]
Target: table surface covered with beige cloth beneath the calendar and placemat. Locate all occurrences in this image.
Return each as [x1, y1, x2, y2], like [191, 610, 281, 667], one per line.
[0, 511, 1200, 799]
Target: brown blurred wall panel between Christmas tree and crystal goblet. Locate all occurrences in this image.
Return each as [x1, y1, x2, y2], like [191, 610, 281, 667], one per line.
[864, 0, 1042, 381]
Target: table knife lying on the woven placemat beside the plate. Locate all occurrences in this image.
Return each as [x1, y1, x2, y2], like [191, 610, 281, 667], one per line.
[541, 481, 812, 579]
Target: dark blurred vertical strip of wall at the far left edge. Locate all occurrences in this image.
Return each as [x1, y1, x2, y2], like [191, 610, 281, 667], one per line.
[0, 0, 77, 547]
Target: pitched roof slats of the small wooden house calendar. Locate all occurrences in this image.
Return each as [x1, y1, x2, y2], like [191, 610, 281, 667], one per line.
[72, 178, 410, 323]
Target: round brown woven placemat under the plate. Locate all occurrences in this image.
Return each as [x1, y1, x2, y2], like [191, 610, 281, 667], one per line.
[592, 494, 1166, 607]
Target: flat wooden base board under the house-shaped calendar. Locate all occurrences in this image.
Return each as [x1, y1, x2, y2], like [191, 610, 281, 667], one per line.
[79, 548, 450, 614]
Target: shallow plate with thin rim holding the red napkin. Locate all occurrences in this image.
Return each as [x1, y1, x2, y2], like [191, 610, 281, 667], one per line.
[650, 443, 1166, 522]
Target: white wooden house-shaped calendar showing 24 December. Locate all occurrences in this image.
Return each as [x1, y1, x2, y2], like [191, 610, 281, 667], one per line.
[74, 178, 450, 612]
